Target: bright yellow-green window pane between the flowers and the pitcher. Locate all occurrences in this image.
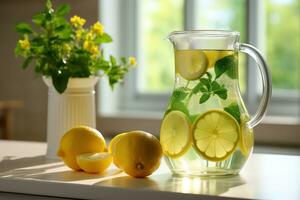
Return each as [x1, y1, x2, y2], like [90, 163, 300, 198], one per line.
[137, 0, 184, 92]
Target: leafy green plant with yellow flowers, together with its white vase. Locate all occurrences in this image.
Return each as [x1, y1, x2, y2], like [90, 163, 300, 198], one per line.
[15, 0, 136, 157]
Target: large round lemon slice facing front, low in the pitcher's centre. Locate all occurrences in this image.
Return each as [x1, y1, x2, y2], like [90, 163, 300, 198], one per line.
[192, 110, 240, 162]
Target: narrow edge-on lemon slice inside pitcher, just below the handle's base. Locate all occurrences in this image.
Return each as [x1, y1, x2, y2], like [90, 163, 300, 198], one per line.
[238, 114, 254, 156]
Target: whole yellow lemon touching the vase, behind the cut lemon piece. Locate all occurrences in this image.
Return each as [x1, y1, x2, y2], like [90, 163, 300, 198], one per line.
[57, 126, 106, 170]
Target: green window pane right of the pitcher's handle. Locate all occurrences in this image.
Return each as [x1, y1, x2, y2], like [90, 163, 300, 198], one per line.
[264, 0, 300, 89]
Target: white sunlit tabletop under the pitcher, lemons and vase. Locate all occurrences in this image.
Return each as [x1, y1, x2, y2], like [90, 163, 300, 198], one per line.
[0, 140, 300, 200]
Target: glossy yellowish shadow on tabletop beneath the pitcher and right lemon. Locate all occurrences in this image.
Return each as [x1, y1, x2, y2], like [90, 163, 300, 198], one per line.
[95, 173, 246, 195]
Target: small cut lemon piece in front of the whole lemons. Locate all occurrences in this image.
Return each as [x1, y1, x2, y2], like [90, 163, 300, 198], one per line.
[76, 152, 112, 173]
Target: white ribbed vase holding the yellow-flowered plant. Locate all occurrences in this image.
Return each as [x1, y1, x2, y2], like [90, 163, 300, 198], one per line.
[43, 77, 98, 159]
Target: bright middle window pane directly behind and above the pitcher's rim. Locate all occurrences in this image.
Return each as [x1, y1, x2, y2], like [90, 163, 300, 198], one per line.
[196, 0, 247, 93]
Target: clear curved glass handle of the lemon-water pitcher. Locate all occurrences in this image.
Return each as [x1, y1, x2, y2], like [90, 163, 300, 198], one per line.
[238, 43, 272, 128]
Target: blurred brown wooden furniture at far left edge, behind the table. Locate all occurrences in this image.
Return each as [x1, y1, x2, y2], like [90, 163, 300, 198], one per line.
[0, 101, 23, 139]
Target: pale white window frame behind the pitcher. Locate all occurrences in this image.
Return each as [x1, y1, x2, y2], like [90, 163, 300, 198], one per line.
[99, 0, 300, 117]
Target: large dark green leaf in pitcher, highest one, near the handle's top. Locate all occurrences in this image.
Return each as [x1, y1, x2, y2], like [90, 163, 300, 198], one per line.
[214, 55, 238, 79]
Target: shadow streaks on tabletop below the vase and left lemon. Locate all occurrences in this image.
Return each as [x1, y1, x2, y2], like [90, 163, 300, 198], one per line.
[0, 156, 121, 182]
